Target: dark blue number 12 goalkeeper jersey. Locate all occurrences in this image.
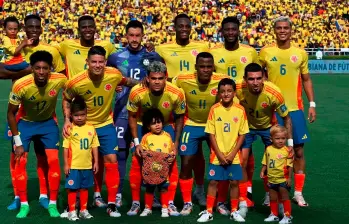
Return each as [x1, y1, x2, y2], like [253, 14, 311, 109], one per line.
[107, 47, 162, 122]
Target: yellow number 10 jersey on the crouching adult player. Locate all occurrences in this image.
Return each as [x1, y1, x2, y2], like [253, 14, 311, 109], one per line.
[64, 67, 126, 128]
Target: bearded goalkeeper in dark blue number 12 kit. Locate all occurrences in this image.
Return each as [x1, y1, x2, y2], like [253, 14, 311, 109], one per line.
[107, 20, 161, 207]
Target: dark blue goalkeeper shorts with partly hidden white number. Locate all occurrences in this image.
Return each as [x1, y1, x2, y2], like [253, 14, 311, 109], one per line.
[115, 119, 132, 149]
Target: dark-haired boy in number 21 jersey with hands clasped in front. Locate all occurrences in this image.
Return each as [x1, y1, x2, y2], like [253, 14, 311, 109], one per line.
[197, 78, 249, 222]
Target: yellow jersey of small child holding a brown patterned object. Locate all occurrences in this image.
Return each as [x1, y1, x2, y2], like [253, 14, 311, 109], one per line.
[141, 131, 173, 153]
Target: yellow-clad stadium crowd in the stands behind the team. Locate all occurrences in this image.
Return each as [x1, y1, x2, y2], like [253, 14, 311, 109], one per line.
[0, 0, 349, 49]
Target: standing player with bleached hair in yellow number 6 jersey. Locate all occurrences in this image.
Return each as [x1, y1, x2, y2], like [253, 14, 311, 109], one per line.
[259, 17, 316, 206]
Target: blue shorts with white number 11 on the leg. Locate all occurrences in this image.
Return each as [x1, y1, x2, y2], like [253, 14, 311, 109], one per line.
[179, 125, 209, 156]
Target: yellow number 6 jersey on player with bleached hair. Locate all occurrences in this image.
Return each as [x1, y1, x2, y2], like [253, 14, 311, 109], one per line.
[259, 44, 309, 111]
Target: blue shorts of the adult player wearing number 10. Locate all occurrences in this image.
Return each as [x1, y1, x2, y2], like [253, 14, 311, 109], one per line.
[96, 124, 118, 156]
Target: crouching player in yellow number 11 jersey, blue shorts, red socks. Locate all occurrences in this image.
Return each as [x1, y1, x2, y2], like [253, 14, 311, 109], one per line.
[175, 52, 228, 215]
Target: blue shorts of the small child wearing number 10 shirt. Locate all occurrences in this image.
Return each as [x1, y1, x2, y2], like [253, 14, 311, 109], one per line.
[65, 169, 93, 190]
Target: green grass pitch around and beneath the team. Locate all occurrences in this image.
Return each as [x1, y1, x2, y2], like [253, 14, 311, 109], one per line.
[0, 75, 349, 224]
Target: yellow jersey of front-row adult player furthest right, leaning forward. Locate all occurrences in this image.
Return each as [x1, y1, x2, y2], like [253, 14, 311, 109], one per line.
[236, 79, 288, 129]
